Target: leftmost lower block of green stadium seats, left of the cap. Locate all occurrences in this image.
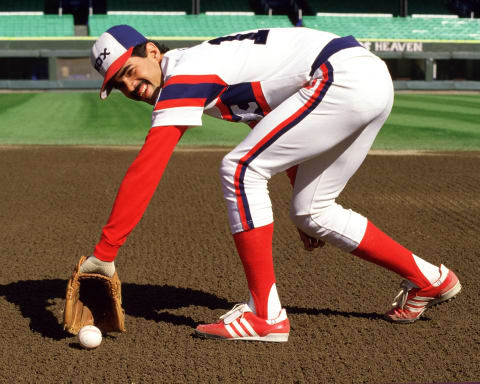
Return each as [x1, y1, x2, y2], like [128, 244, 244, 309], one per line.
[0, 15, 75, 37]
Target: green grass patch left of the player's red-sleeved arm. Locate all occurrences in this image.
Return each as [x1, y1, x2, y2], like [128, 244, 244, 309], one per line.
[0, 93, 151, 145]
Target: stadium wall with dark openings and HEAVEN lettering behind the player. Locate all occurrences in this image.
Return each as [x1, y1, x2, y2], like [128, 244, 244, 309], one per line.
[0, 37, 480, 90]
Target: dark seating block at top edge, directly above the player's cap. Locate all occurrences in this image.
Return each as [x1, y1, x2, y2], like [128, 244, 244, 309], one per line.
[107, 0, 192, 13]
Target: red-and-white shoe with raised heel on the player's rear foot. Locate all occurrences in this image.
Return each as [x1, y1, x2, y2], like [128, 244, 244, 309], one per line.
[385, 264, 462, 323]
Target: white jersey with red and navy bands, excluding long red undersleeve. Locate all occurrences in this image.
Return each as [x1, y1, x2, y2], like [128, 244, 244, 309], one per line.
[152, 28, 338, 126]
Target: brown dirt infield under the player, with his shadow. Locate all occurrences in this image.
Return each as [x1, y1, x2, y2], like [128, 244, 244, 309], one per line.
[0, 147, 480, 383]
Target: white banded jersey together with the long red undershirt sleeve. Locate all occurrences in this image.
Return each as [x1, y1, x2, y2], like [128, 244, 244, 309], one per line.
[94, 28, 358, 261]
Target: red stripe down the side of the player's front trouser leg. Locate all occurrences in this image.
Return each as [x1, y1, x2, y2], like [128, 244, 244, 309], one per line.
[234, 64, 330, 231]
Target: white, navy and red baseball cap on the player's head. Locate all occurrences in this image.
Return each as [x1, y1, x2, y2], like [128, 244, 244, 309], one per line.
[90, 25, 147, 99]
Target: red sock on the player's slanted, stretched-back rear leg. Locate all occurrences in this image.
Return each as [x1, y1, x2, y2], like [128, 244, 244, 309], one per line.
[352, 221, 430, 288]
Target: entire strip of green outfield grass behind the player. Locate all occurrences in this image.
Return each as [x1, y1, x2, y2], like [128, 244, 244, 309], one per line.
[0, 92, 480, 150]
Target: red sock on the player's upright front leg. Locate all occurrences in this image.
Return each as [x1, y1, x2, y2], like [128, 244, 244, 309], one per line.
[233, 223, 275, 319]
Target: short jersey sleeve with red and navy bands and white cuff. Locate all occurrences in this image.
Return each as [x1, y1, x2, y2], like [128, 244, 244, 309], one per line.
[152, 75, 227, 126]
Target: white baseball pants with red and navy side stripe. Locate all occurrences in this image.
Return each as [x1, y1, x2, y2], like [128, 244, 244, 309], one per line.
[220, 47, 393, 252]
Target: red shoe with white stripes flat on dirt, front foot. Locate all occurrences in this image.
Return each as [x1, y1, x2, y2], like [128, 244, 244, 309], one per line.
[195, 303, 290, 342]
